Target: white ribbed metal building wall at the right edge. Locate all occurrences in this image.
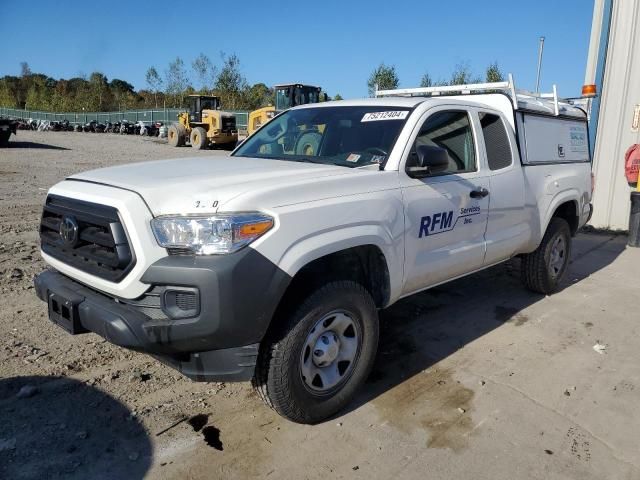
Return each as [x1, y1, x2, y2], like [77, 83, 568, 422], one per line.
[585, 0, 640, 230]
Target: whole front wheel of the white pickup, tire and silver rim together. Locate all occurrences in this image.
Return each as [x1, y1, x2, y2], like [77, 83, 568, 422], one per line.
[254, 281, 379, 424]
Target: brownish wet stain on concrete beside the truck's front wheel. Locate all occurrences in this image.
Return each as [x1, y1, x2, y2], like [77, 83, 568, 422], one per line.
[373, 369, 474, 452]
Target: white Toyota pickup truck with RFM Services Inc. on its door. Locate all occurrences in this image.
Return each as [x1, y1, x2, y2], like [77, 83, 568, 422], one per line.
[35, 79, 592, 423]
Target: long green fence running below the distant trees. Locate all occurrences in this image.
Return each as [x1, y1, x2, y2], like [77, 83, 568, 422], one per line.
[0, 107, 249, 129]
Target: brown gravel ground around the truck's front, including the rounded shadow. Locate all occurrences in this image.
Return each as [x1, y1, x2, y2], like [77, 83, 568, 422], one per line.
[0, 131, 240, 478]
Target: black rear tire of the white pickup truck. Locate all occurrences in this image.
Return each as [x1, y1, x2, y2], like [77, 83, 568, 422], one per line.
[521, 217, 571, 295]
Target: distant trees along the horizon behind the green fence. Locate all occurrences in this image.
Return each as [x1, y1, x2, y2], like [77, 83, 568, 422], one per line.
[0, 53, 504, 112]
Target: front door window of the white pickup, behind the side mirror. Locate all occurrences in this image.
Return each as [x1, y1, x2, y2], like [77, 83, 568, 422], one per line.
[407, 110, 477, 175]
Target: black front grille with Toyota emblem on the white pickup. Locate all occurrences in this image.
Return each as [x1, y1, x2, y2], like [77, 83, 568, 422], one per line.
[40, 195, 135, 282]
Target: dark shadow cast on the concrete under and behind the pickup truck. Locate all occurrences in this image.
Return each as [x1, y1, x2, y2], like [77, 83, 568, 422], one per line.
[343, 234, 625, 415]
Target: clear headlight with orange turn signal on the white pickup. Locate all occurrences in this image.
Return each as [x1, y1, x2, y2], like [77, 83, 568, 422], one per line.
[151, 213, 273, 255]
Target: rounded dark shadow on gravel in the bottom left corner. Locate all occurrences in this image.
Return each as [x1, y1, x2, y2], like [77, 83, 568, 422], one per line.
[0, 376, 152, 480]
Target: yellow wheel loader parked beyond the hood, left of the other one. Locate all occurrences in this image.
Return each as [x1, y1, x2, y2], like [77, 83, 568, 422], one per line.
[167, 95, 238, 150]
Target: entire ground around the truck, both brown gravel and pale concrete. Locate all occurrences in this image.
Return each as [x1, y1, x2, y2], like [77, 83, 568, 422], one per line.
[0, 131, 640, 480]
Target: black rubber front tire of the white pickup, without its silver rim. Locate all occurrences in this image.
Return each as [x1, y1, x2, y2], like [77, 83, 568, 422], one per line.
[253, 281, 379, 424]
